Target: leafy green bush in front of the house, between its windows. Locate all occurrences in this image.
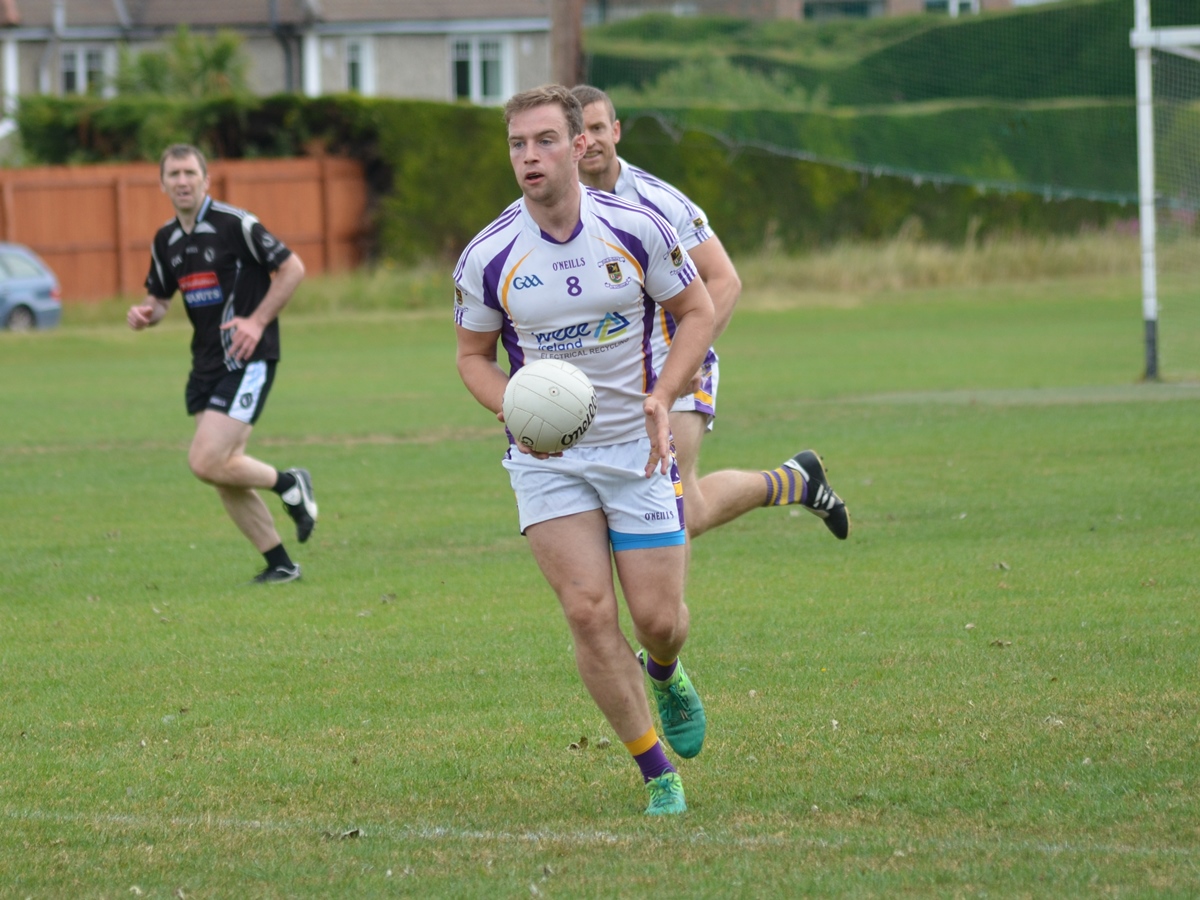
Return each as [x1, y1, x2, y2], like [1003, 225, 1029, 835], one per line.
[115, 25, 248, 100]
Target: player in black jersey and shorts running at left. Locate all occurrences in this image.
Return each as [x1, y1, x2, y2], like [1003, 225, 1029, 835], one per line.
[126, 144, 317, 583]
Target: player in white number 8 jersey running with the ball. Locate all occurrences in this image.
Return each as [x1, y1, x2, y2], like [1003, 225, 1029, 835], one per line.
[454, 85, 713, 815]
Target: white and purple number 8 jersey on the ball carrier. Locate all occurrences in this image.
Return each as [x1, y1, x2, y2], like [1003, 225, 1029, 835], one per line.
[454, 185, 696, 446]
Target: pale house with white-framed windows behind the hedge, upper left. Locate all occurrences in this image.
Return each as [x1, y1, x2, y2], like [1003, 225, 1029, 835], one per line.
[0, 0, 553, 110]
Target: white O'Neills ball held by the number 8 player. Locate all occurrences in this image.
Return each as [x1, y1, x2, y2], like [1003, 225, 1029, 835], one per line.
[504, 359, 596, 454]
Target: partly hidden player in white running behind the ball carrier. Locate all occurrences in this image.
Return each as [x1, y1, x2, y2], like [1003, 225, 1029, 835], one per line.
[571, 84, 850, 540]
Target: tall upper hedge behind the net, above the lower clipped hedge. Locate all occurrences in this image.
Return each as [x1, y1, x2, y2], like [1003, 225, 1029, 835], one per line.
[584, 0, 1198, 101]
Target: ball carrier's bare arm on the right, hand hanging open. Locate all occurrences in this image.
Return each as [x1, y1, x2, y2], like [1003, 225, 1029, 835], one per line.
[642, 278, 714, 478]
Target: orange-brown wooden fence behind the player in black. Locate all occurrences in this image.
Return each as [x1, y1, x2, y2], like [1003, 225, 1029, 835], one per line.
[0, 157, 367, 302]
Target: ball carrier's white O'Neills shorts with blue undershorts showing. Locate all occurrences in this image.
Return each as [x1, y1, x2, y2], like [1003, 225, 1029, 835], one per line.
[504, 437, 685, 551]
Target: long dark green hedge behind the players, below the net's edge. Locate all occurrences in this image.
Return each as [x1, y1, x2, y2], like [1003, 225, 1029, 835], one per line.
[11, 95, 1133, 262]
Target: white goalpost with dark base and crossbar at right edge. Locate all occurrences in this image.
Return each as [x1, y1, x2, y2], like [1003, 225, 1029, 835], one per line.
[1129, 0, 1200, 380]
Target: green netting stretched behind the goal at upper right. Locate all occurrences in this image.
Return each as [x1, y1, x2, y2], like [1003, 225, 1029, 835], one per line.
[586, 0, 1196, 204]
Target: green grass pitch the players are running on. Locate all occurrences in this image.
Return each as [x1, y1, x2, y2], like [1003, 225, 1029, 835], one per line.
[0, 259, 1200, 898]
